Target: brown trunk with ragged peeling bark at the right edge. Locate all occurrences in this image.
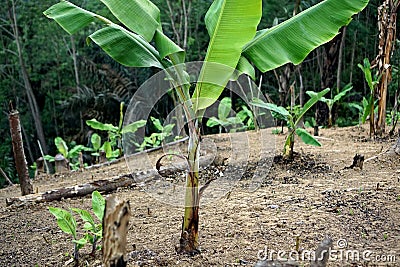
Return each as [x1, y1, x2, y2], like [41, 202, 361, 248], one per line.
[375, 0, 400, 135]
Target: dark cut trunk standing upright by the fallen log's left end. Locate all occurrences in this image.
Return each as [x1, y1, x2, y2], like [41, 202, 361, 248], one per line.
[8, 110, 33, 196]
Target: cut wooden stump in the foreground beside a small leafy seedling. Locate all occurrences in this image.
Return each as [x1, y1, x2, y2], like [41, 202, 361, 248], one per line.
[102, 196, 130, 267]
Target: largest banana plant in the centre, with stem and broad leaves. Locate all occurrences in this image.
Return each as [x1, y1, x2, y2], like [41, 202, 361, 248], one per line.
[44, 0, 368, 253]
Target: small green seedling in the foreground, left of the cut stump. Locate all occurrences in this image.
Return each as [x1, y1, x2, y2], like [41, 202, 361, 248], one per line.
[49, 191, 105, 261]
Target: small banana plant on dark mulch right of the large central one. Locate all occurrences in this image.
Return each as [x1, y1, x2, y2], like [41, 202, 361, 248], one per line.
[252, 88, 330, 158]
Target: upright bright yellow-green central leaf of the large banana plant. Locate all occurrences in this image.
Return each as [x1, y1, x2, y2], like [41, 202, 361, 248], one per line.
[193, 0, 262, 111]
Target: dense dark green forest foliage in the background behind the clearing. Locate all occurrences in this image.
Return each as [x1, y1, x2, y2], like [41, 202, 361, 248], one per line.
[0, 0, 400, 187]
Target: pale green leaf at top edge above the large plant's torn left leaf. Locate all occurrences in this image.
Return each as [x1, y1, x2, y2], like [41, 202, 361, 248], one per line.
[101, 0, 160, 42]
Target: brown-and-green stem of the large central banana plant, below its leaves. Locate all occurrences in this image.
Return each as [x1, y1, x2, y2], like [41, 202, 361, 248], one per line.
[178, 123, 200, 254]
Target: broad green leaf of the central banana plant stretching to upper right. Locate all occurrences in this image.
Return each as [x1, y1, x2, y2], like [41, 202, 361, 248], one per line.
[243, 0, 369, 72]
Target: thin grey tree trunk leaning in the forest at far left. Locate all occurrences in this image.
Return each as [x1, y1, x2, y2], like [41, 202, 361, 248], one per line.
[10, 0, 48, 154]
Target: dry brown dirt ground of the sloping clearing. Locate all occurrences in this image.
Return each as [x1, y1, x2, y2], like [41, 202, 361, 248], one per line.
[0, 127, 400, 266]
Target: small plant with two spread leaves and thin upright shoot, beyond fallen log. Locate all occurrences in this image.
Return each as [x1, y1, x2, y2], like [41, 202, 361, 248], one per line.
[86, 102, 146, 159]
